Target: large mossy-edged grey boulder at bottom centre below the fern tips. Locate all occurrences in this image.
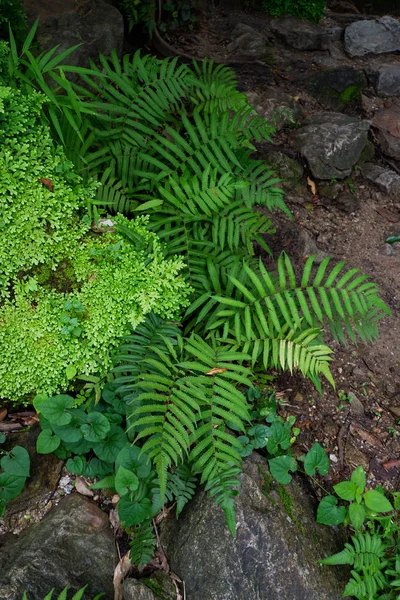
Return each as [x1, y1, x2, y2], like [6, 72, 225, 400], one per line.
[161, 454, 344, 600]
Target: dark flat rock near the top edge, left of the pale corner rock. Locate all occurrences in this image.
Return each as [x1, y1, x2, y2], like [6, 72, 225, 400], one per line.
[271, 16, 331, 50]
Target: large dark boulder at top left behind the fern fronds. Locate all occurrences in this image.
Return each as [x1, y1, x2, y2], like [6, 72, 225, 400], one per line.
[37, 0, 124, 67]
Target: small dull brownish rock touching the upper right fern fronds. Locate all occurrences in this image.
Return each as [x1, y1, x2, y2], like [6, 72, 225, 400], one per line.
[245, 88, 302, 131]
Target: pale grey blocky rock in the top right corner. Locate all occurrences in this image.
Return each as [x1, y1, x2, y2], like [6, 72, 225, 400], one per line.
[344, 16, 400, 56]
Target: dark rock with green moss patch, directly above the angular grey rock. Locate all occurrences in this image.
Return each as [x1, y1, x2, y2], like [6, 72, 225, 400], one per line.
[310, 66, 366, 109]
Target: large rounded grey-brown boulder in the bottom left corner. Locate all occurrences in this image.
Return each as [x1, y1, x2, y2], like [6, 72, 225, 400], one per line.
[0, 494, 115, 600]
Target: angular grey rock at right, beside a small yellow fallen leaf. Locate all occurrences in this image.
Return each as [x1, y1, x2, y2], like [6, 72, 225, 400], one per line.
[294, 112, 370, 179]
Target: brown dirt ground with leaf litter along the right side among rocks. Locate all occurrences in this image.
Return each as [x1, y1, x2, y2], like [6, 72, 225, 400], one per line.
[169, 2, 400, 490]
